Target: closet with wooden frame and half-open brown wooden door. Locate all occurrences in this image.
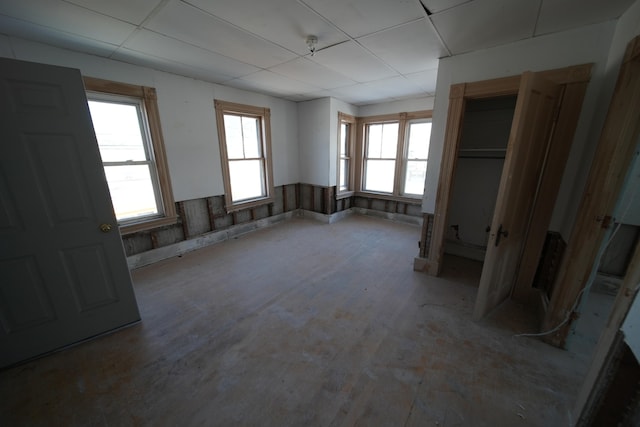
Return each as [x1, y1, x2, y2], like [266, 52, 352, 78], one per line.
[422, 64, 591, 319]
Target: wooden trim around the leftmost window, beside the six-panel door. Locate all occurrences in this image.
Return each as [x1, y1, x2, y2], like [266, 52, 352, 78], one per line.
[83, 76, 178, 235]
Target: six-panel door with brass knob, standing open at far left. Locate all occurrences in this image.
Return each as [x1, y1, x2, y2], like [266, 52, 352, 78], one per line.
[0, 58, 140, 367]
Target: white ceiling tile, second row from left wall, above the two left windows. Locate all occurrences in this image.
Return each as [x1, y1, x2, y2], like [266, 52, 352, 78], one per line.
[124, 30, 259, 77]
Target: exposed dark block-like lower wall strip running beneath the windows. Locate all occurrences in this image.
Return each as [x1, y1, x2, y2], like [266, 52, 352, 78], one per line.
[122, 184, 430, 256]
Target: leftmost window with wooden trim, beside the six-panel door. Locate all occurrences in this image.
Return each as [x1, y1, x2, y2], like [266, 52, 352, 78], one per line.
[84, 77, 176, 234]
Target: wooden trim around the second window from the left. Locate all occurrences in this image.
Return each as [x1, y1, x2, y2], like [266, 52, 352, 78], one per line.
[214, 99, 274, 213]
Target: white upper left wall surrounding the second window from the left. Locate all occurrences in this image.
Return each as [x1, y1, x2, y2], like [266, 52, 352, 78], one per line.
[0, 36, 300, 201]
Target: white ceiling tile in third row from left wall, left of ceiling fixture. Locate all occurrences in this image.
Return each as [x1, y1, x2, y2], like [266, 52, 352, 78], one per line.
[145, 1, 296, 68]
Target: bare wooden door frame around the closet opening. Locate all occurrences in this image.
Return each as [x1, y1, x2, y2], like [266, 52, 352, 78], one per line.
[423, 64, 593, 284]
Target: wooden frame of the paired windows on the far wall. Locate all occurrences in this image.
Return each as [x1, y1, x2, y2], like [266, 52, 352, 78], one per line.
[355, 110, 432, 203]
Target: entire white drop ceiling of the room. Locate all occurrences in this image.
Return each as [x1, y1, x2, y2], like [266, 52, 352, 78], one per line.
[0, 0, 634, 105]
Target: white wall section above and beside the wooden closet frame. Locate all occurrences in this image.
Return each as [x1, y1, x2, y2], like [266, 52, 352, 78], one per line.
[422, 21, 615, 241]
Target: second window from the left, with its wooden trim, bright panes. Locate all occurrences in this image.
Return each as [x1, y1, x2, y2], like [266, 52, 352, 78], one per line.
[215, 100, 273, 212]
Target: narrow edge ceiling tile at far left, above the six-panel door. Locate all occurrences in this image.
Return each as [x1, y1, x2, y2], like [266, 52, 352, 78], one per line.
[0, 15, 118, 57]
